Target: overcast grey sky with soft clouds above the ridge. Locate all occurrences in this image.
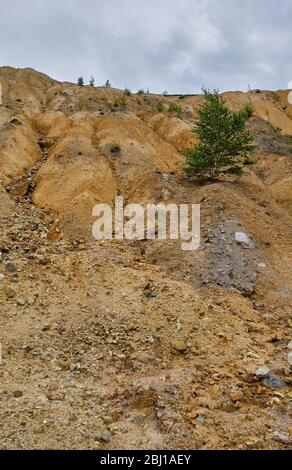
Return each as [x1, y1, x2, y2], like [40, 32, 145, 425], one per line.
[0, 0, 292, 93]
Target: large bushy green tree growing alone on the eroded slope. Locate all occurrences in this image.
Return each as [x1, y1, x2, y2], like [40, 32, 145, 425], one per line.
[185, 89, 256, 180]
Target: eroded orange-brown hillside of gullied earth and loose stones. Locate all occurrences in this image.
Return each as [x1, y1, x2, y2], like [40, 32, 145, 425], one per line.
[0, 67, 292, 449]
